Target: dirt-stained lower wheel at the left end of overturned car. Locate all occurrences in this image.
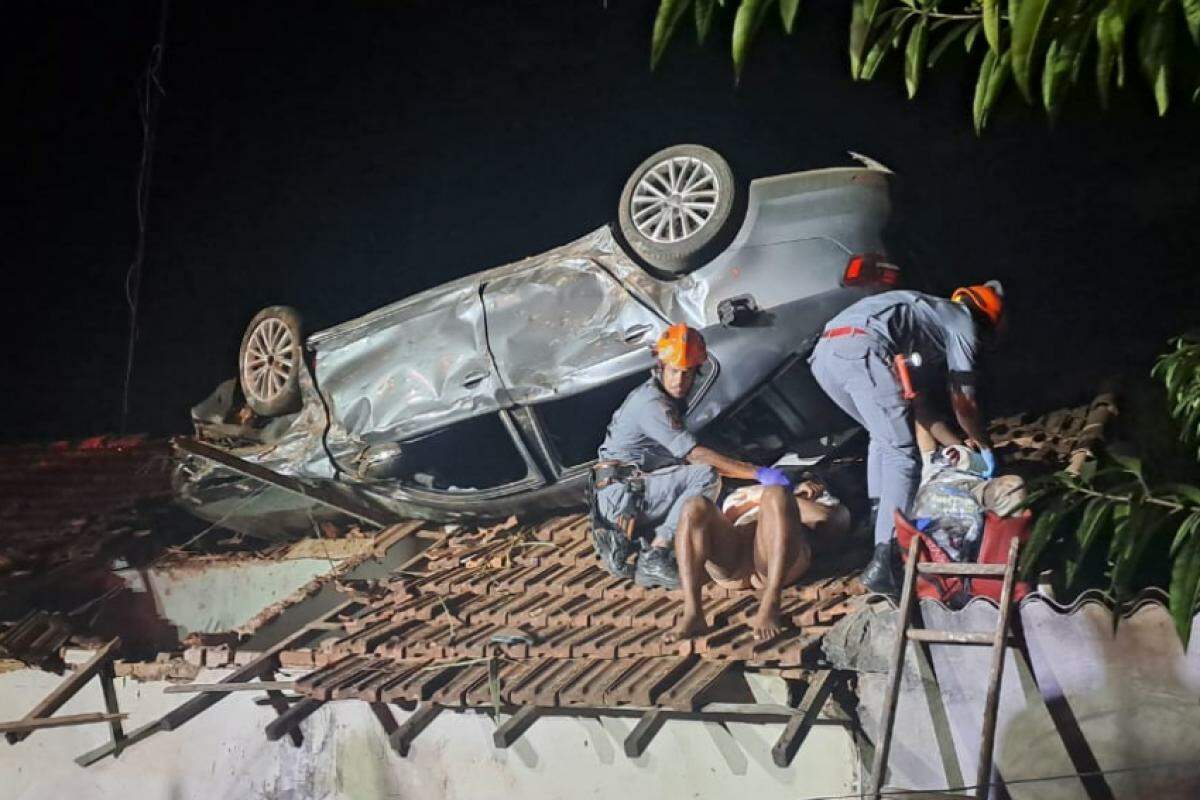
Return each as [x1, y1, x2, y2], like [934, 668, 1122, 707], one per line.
[238, 306, 302, 416]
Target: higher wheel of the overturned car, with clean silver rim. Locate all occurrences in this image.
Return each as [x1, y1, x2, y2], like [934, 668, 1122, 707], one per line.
[617, 144, 745, 276]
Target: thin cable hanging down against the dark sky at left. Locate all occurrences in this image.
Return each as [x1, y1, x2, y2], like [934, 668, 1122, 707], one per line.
[121, 0, 168, 434]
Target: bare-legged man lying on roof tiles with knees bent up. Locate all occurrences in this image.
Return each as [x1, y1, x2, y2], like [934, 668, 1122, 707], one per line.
[668, 481, 850, 642]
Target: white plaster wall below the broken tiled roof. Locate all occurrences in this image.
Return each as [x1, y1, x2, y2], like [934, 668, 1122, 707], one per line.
[0, 670, 858, 800]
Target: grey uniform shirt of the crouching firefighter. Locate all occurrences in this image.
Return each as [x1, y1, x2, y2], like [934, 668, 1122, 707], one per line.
[600, 378, 697, 473]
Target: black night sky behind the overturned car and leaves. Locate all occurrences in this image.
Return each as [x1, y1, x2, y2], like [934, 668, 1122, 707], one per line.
[0, 0, 1200, 440]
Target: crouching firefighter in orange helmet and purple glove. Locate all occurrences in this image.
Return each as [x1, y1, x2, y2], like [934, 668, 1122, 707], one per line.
[592, 324, 790, 589]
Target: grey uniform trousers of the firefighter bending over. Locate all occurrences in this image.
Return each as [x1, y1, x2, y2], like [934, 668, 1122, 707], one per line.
[811, 336, 920, 545]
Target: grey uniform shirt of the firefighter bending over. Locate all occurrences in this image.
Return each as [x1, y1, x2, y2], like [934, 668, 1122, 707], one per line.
[826, 289, 979, 384]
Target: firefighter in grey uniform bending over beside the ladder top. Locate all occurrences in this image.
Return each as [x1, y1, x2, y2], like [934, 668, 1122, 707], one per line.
[809, 281, 1003, 594]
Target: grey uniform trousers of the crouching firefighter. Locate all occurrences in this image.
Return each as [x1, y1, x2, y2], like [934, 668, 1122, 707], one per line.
[595, 464, 721, 543]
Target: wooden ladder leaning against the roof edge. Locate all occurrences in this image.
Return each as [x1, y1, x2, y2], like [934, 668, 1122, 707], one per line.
[871, 536, 1019, 800]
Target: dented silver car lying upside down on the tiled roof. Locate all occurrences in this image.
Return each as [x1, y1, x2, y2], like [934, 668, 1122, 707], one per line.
[175, 145, 898, 534]
